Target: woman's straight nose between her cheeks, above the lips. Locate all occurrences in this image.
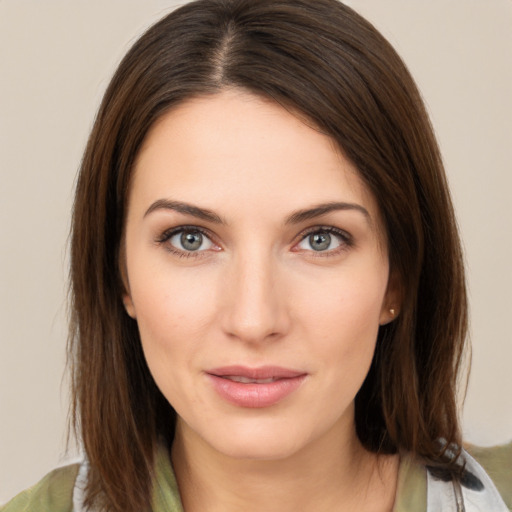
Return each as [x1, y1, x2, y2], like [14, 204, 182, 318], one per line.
[221, 251, 290, 344]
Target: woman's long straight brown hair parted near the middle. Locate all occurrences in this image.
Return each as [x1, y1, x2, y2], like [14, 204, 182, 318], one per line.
[69, 0, 467, 511]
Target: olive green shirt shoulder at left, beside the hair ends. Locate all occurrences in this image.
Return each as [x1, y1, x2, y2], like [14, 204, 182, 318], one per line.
[0, 464, 80, 512]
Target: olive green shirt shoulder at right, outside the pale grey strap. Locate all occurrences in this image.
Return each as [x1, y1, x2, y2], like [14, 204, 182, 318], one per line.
[465, 442, 512, 510]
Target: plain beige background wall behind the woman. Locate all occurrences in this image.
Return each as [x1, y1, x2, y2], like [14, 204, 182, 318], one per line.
[0, 0, 512, 503]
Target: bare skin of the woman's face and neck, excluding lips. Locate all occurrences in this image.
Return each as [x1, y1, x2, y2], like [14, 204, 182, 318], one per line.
[123, 90, 398, 512]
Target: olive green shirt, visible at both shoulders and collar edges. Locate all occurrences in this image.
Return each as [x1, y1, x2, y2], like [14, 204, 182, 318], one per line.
[0, 443, 512, 512]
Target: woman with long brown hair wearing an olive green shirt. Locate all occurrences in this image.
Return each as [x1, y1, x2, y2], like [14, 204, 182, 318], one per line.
[2, 0, 511, 512]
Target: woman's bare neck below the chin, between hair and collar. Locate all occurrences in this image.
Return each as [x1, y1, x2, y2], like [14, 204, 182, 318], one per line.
[172, 422, 398, 512]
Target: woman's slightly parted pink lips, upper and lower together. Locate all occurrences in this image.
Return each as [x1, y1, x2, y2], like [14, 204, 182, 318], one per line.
[205, 366, 307, 408]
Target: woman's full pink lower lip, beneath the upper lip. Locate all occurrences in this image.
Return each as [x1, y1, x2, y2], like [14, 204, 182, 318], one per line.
[207, 374, 306, 409]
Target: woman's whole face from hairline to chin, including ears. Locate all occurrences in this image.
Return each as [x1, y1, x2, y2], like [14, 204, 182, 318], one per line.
[123, 91, 394, 459]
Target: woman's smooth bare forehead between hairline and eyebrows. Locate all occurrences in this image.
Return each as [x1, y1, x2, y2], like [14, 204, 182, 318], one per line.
[130, 90, 378, 228]
